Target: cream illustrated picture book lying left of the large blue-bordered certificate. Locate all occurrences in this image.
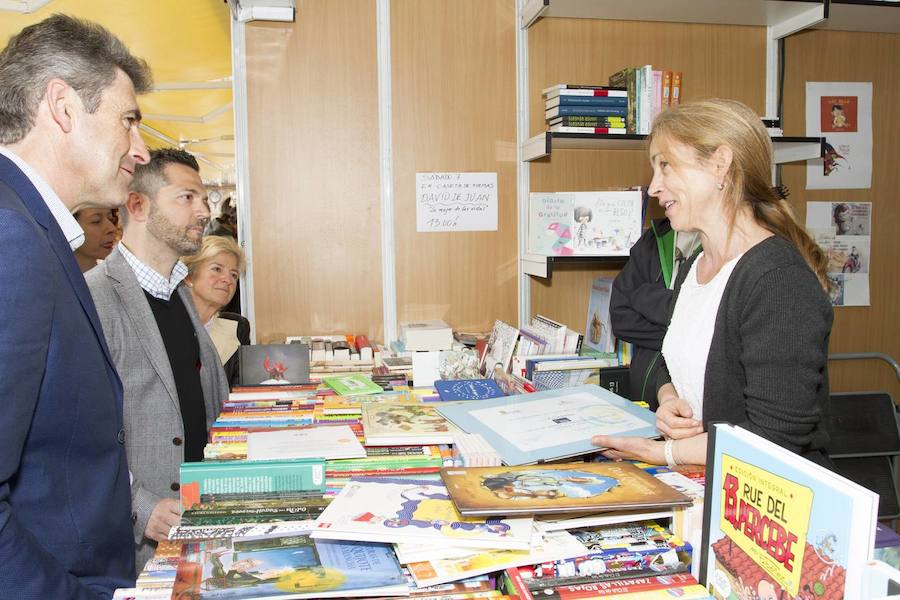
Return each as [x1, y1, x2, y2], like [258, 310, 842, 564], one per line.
[362, 402, 457, 446]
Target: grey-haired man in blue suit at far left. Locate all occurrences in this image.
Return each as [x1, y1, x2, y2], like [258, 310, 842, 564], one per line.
[0, 15, 151, 600]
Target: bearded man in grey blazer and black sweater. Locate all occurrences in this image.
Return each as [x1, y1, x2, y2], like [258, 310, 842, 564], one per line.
[85, 148, 228, 570]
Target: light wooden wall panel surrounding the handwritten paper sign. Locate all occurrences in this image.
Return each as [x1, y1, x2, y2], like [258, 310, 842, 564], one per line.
[391, 0, 517, 331]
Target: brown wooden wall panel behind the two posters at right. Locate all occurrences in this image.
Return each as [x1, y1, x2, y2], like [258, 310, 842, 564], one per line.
[782, 31, 900, 401]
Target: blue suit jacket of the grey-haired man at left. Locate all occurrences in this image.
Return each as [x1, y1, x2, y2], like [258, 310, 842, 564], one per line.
[0, 155, 134, 600]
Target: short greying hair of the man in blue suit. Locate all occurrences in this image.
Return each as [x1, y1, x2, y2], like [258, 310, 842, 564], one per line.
[0, 14, 153, 144]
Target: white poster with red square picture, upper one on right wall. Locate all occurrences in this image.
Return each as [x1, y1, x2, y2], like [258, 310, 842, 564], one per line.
[806, 81, 872, 190]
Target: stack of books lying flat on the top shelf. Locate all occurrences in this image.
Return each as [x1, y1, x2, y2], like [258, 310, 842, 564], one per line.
[542, 83, 628, 134]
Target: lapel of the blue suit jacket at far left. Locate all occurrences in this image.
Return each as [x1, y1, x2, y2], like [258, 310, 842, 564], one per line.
[0, 155, 122, 400]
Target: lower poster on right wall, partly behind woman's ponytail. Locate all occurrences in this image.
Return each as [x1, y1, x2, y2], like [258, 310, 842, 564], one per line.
[806, 202, 872, 306]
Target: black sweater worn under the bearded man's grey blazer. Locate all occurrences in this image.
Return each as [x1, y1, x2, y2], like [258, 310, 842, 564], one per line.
[144, 291, 207, 462]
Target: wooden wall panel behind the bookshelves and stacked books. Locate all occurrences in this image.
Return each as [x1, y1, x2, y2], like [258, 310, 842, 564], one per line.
[528, 18, 766, 330]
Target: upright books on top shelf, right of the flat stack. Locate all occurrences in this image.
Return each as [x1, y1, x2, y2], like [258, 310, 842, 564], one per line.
[609, 65, 683, 135]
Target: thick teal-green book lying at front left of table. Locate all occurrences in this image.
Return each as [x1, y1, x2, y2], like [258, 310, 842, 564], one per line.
[180, 459, 325, 510]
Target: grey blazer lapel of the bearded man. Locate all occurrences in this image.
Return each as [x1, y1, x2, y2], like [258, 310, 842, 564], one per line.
[105, 248, 181, 410]
